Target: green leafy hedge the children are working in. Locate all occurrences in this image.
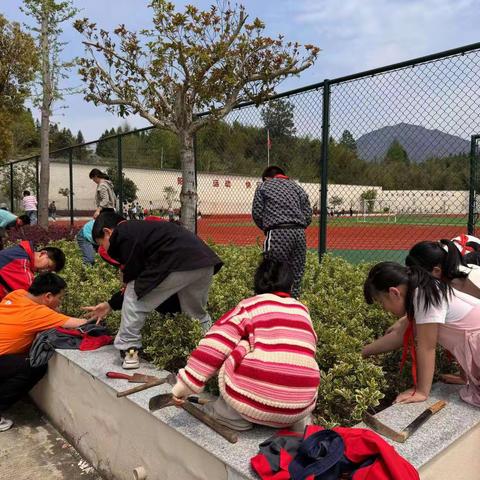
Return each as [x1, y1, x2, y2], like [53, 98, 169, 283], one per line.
[56, 241, 450, 426]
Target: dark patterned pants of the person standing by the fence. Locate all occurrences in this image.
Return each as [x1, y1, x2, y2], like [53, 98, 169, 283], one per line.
[263, 228, 307, 298]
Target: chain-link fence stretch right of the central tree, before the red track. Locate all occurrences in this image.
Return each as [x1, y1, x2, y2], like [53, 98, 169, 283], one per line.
[197, 44, 480, 262]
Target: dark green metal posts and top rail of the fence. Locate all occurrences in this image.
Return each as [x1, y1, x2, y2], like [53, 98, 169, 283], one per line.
[5, 42, 480, 260]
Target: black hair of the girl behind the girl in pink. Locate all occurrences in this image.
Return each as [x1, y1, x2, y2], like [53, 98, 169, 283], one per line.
[405, 239, 467, 281]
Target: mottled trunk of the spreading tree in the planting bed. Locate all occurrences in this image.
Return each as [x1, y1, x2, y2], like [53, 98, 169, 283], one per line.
[179, 132, 197, 232]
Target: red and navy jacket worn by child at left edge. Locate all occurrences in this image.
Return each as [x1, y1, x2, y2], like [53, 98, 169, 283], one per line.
[0, 240, 35, 300]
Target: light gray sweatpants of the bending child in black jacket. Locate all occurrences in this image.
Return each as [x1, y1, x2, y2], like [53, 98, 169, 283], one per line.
[114, 267, 213, 350]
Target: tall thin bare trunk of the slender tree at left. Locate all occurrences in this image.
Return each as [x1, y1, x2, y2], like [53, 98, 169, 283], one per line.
[38, 7, 52, 228]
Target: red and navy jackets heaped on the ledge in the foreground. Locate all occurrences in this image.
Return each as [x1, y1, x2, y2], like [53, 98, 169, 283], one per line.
[251, 425, 420, 480]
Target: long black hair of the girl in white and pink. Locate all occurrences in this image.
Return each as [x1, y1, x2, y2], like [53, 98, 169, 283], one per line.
[363, 262, 450, 320]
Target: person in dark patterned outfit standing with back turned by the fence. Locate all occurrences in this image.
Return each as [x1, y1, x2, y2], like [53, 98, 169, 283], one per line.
[252, 165, 312, 298]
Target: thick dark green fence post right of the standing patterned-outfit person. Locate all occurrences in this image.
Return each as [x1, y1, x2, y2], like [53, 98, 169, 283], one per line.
[318, 80, 330, 262]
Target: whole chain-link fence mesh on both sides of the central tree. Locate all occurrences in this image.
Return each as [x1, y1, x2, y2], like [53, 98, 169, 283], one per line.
[0, 44, 480, 262]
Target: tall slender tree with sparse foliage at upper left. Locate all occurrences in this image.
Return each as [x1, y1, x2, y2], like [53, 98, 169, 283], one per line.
[23, 0, 77, 227]
